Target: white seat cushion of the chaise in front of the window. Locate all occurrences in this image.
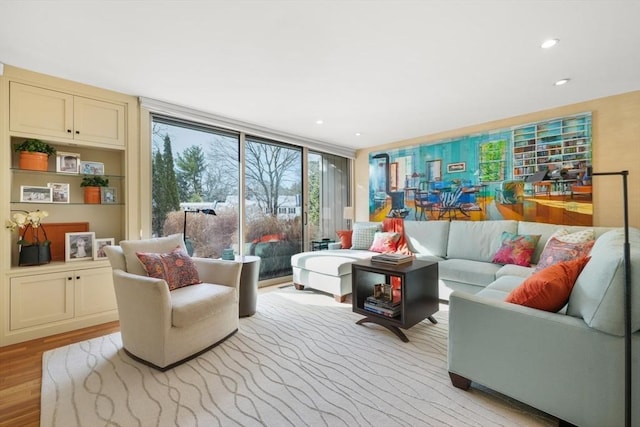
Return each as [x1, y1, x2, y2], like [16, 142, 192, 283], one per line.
[291, 249, 377, 276]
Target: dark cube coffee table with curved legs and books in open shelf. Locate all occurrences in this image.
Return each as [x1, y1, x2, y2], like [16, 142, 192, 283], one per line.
[351, 260, 440, 342]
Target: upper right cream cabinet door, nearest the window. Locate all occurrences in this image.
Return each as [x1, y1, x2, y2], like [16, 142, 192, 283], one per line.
[73, 96, 125, 147]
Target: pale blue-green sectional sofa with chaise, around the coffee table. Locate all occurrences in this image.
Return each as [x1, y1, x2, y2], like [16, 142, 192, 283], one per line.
[292, 220, 640, 427]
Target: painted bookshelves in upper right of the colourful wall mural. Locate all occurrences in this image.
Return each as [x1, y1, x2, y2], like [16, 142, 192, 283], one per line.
[512, 113, 591, 179]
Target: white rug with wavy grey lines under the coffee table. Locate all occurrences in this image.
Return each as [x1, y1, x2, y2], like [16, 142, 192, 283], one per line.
[41, 288, 557, 427]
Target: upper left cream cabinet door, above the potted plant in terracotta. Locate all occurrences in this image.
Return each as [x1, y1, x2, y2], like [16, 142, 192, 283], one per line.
[9, 82, 73, 139]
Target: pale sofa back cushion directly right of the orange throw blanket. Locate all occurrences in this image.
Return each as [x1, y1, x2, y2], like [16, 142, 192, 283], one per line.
[404, 221, 451, 258]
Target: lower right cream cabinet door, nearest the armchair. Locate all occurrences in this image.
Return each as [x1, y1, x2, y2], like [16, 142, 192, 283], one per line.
[74, 267, 116, 317]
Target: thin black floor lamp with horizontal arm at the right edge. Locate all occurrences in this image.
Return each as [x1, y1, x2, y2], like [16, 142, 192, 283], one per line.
[591, 171, 631, 427]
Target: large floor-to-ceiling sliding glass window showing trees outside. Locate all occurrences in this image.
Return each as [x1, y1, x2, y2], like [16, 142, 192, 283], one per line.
[152, 115, 349, 280]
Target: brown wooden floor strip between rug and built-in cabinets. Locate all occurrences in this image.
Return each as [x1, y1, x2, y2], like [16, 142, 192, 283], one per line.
[0, 322, 120, 427]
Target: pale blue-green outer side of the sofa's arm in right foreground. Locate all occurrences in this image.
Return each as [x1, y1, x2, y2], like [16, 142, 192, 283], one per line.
[448, 292, 624, 425]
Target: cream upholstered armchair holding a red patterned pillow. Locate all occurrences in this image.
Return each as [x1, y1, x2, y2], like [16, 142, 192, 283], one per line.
[105, 234, 242, 371]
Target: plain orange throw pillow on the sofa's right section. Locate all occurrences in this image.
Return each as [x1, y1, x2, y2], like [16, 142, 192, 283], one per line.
[505, 257, 591, 313]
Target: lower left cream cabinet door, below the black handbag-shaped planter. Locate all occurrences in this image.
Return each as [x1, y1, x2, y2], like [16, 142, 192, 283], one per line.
[10, 272, 74, 330]
